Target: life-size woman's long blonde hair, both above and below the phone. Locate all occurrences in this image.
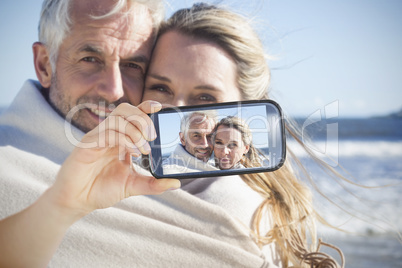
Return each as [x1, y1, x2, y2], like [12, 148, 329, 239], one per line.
[163, 4, 342, 267]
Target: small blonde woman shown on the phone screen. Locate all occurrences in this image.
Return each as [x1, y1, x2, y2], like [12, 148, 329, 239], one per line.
[212, 116, 260, 169]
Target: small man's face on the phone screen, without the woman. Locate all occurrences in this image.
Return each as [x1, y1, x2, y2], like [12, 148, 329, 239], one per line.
[180, 115, 215, 162]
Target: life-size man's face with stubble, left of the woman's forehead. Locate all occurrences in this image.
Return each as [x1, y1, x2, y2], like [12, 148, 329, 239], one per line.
[49, 0, 153, 132]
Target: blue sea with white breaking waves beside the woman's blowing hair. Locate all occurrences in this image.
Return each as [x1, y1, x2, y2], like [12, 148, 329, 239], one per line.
[288, 116, 402, 268]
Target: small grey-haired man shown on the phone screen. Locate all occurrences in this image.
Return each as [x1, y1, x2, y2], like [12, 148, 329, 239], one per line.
[163, 111, 217, 174]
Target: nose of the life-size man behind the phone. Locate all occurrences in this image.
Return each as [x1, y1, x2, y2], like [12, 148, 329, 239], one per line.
[98, 64, 124, 102]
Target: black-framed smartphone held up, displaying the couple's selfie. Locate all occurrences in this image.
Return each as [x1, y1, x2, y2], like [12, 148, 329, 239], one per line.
[149, 100, 286, 179]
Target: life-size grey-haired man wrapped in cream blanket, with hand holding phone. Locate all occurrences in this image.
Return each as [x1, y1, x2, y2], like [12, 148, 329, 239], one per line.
[0, 0, 270, 267]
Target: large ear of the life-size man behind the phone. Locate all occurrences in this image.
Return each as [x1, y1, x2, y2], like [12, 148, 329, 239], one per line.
[32, 42, 52, 88]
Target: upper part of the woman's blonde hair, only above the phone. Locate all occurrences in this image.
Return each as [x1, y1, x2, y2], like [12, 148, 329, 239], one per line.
[159, 4, 270, 100]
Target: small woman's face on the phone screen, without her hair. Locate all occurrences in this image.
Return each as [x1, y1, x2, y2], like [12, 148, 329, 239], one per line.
[214, 126, 249, 169]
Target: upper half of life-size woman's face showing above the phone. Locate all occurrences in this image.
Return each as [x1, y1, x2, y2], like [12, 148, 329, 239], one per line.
[143, 31, 241, 107]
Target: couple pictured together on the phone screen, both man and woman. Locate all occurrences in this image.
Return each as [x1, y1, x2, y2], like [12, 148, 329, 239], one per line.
[163, 110, 260, 174]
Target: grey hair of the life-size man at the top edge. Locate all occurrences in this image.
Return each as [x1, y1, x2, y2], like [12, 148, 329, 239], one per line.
[38, 0, 165, 72]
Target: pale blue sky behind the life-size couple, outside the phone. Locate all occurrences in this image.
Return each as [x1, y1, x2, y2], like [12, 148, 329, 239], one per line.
[0, 0, 402, 117]
